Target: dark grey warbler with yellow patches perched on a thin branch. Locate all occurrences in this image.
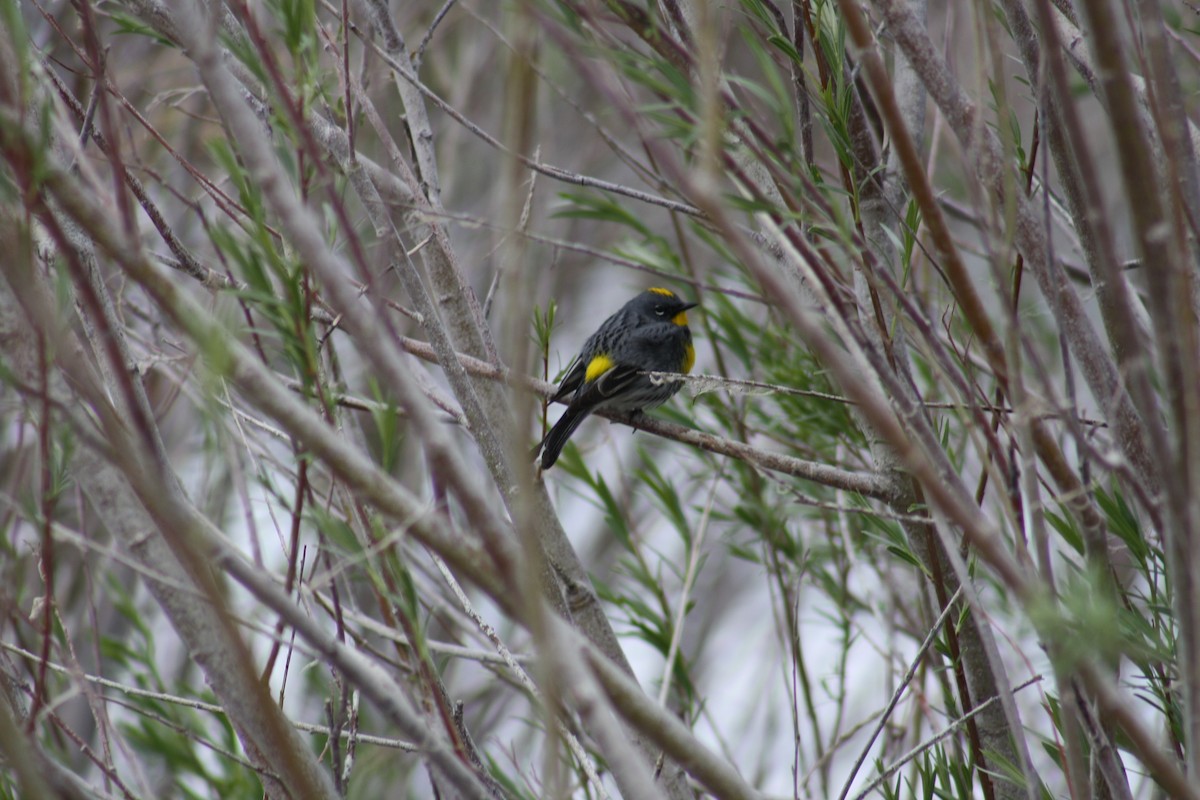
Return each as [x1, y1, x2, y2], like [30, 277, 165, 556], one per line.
[535, 287, 696, 469]
